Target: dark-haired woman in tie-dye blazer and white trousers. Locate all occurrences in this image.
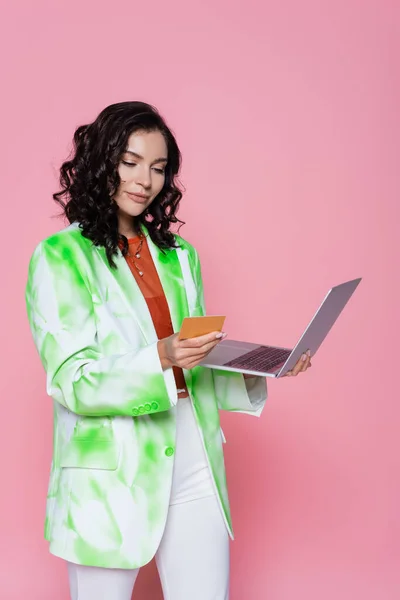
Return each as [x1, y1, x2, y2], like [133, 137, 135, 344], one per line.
[26, 102, 310, 600]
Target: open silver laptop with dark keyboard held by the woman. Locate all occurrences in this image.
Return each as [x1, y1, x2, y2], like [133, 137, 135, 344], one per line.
[200, 277, 362, 377]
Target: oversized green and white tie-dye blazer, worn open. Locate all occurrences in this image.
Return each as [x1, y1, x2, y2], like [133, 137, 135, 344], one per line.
[26, 224, 267, 568]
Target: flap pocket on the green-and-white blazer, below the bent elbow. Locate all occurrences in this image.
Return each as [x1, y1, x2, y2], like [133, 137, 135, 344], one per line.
[60, 438, 119, 471]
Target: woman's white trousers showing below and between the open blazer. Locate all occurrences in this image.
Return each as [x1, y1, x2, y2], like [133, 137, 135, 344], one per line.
[68, 400, 229, 600]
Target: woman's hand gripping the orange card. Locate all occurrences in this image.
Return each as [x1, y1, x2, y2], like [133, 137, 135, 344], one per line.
[158, 331, 226, 371]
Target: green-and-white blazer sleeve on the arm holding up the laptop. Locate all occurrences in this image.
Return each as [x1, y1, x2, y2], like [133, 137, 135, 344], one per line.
[193, 246, 268, 417]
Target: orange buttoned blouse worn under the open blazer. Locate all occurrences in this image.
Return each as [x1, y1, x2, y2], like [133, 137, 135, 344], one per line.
[121, 236, 189, 398]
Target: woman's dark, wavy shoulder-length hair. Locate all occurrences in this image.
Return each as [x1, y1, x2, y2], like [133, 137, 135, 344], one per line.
[53, 102, 184, 267]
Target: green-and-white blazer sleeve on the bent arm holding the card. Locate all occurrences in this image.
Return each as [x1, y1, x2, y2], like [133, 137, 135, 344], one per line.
[26, 241, 177, 416]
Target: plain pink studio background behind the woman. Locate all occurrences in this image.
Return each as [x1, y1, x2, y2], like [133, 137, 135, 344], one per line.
[0, 0, 400, 600]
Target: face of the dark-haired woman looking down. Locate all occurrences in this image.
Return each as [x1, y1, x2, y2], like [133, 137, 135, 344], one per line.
[114, 131, 168, 221]
